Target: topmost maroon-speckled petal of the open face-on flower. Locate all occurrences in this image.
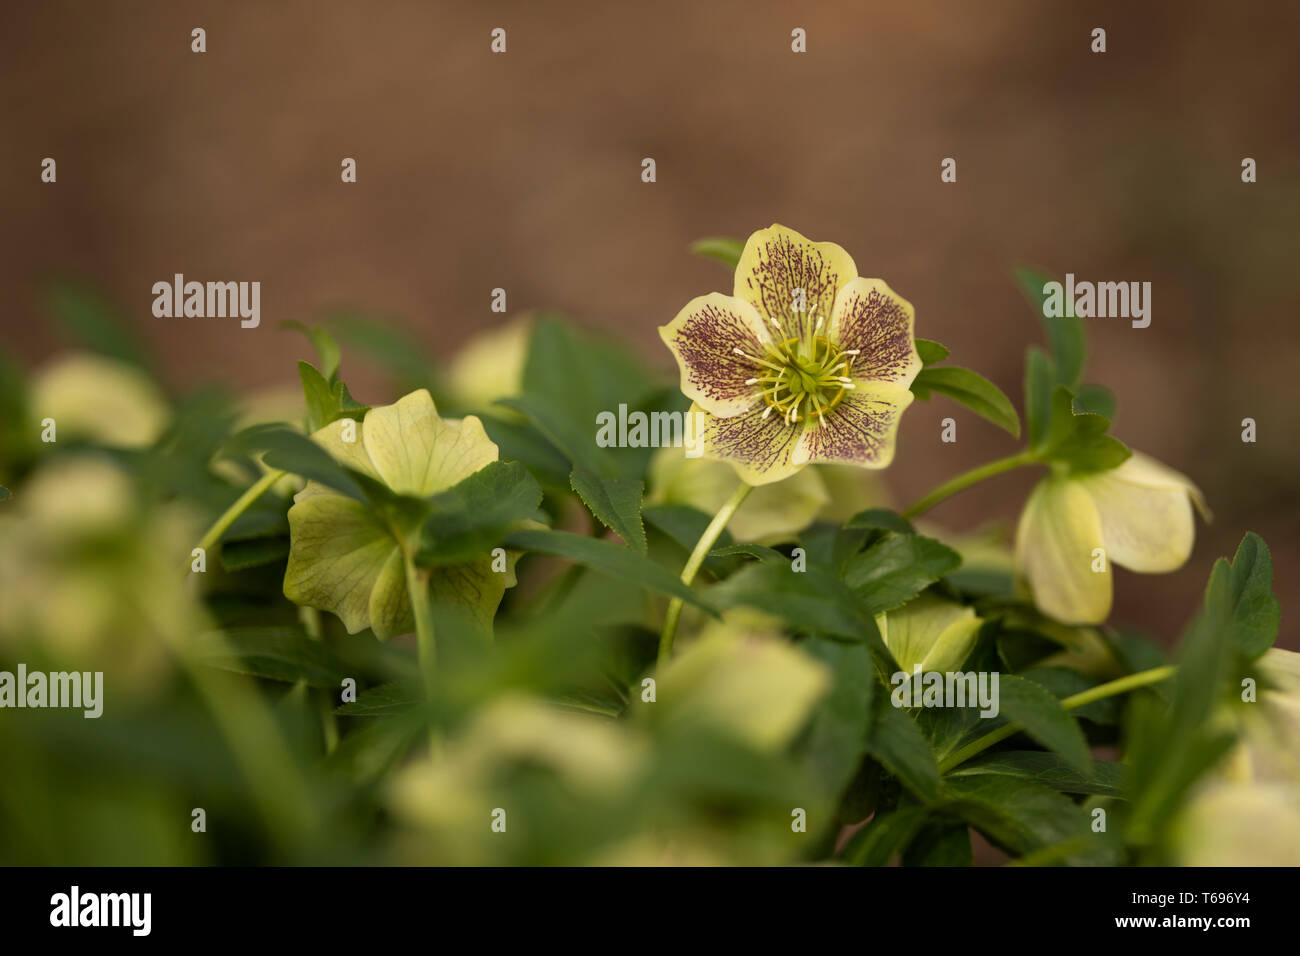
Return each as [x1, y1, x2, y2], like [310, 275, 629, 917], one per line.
[735, 225, 858, 338]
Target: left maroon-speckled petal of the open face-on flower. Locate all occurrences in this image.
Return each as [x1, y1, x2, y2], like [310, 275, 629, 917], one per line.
[659, 293, 771, 418]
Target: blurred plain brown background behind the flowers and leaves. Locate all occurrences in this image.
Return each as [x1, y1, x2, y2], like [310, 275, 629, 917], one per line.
[0, 0, 1300, 646]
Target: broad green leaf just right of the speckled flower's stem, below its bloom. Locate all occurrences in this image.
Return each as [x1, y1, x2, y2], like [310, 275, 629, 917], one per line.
[706, 561, 880, 643]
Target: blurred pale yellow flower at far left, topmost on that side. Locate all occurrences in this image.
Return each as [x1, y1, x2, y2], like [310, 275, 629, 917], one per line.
[29, 352, 170, 447]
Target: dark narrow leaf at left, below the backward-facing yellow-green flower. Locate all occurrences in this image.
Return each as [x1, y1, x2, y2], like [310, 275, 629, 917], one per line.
[195, 627, 348, 688]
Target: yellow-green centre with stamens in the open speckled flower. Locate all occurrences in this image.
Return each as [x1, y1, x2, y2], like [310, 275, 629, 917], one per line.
[750, 334, 857, 423]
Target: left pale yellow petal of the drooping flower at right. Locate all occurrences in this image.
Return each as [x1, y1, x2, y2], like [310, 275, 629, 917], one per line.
[1015, 477, 1112, 624]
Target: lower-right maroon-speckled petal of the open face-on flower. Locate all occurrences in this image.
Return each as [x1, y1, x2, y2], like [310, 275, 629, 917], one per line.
[793, 378, 913, 468]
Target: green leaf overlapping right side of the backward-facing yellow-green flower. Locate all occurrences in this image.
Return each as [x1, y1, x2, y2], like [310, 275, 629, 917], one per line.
[416, 462, 542, 566]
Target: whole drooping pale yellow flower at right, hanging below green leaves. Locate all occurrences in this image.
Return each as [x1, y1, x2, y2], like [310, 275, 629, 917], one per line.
[1015, 453, 1209, 624]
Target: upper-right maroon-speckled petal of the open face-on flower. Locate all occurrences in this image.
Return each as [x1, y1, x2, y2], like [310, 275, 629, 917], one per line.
[829, 278, 920, 388]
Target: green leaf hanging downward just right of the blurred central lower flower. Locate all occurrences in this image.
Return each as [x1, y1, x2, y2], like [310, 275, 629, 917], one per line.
[800, 636, 879, 797]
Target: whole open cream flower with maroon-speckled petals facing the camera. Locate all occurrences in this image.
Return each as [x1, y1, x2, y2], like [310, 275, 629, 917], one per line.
[659, 225, 920, 485]
